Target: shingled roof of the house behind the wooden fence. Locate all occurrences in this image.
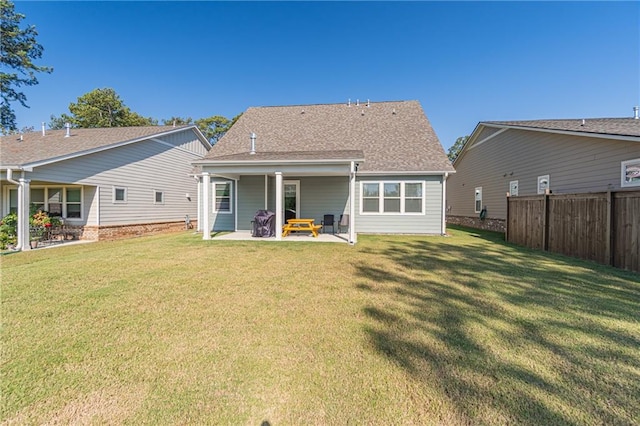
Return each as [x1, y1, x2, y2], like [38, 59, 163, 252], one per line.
[480, 117, 640, 136]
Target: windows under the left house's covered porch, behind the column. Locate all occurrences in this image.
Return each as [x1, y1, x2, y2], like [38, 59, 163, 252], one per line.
[9, 187, 82, 219]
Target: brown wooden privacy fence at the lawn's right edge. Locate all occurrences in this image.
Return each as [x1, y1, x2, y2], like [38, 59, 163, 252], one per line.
[506, 191, 640, 272]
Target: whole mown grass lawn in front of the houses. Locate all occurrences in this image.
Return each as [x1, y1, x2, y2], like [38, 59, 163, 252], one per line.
[0, 229, 640, 425]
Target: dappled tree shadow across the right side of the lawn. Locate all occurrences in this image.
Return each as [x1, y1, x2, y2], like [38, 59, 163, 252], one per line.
[358, 229, 640, 424]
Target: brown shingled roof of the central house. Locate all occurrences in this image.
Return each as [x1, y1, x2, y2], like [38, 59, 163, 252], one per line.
[204, 101, 453, 172]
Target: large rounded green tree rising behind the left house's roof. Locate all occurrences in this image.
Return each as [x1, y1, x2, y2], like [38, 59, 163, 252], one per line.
[50, 88, 158, 129]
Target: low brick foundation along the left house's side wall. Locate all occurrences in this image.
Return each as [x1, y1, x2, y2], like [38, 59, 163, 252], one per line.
[72, 220, 193, 241]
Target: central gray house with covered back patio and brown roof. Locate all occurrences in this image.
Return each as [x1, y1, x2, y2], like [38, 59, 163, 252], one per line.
[194, 101, 454, 243]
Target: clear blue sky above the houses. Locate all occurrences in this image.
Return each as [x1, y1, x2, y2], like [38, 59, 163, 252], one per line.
[14, 1, 640, 149]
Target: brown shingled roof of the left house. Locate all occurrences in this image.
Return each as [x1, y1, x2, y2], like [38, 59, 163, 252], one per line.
[0, 126, 205, 167]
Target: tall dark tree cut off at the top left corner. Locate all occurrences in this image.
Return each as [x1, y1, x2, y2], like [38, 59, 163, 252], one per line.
[0, 0, 53, 133]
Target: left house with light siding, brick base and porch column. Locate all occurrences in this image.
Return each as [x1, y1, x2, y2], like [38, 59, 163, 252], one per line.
[0, 126, 211, 248]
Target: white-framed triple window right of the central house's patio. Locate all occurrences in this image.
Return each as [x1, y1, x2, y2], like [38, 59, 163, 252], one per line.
[360, 181, 424, 214]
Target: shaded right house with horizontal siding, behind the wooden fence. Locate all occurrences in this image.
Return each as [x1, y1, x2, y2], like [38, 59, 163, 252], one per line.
[447, 116, 640, 231]
